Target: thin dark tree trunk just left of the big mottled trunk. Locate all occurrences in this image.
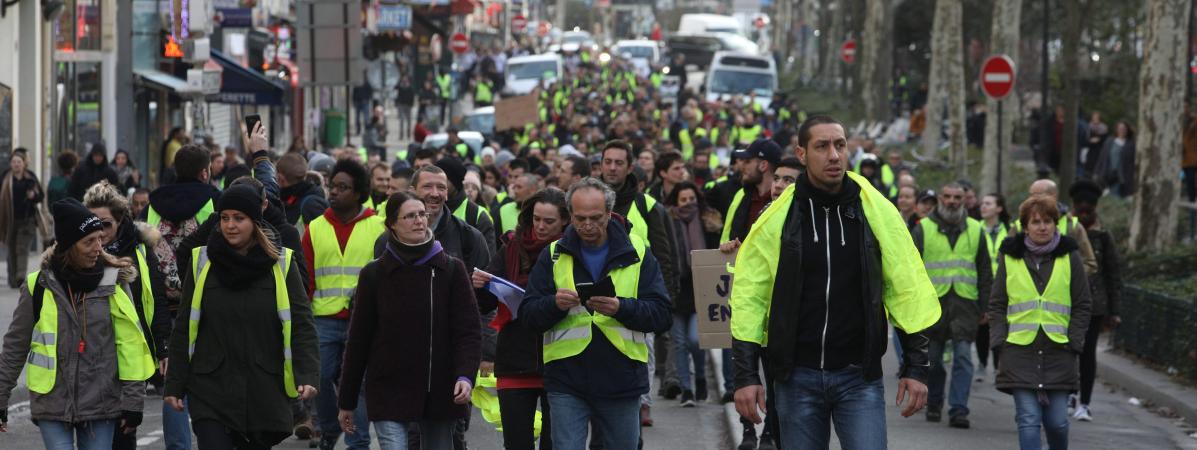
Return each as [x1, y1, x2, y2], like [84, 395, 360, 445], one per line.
[1057, 0, 1089, 203]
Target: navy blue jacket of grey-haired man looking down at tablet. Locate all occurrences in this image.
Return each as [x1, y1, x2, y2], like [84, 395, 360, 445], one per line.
[519, 218, 673, 399]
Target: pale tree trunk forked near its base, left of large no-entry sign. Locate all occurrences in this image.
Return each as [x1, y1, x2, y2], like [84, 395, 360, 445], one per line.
[923, 0, 965, 167]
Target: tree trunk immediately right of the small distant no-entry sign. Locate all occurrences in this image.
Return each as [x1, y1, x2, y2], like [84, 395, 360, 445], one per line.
[858, 0, 893, 123]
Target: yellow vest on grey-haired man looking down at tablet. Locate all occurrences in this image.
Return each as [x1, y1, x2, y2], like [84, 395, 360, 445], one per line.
[545, 235, 649, 364]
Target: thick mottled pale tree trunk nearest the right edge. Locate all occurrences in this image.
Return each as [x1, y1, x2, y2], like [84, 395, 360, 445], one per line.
[1130, 0, 1191, 251]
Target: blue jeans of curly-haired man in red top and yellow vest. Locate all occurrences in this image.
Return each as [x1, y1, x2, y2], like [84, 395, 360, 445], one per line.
[316, 317, 370, 450]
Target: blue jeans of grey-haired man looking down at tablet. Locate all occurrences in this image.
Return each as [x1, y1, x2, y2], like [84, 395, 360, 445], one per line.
[548, 393, 640, 450]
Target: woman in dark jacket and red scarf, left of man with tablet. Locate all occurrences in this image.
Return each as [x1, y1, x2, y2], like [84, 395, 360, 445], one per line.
[472, 189, 570, 450]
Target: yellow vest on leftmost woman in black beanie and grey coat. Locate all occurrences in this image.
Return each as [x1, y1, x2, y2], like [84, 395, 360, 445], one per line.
[25, 270, 157, 394]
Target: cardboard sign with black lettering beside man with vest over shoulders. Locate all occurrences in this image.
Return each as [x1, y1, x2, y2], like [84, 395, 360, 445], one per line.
[689, 249, 736, 348]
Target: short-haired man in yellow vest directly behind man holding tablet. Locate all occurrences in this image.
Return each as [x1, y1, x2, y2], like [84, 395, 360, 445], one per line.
[602, 140, 681, 425]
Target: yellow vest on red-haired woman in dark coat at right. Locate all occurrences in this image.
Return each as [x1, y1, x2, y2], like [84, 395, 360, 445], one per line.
[1005, 255, 1073, 346]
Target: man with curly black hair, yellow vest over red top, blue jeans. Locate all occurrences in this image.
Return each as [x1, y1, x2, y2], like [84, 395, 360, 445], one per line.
[303, 159, 385, 449]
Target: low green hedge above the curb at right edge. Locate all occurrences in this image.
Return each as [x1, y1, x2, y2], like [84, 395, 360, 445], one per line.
[1113, 285, 1197, 383]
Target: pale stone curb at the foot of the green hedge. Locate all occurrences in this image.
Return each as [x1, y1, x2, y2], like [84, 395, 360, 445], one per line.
[1098, 339, 1197, 424]
